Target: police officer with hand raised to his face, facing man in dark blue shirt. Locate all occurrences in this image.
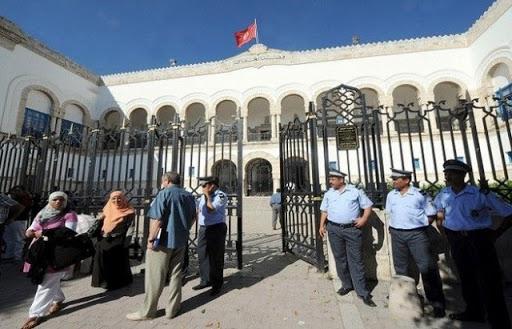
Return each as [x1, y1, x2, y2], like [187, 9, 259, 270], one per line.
[192, 176, 228, 296]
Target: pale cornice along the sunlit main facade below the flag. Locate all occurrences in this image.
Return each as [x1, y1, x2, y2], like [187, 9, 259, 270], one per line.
[102, 0, 512, 86]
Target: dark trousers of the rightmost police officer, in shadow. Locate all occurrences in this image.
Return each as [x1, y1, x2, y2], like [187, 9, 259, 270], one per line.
[445, 229, 510, 329]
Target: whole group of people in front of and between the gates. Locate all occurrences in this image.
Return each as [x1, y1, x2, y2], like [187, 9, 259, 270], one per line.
[0, 159, 512, 329]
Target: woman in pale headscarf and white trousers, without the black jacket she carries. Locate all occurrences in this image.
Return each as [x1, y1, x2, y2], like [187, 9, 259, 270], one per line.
[22, 191, 77, 329]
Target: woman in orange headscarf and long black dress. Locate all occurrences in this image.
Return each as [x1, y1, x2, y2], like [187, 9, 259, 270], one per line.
[92, 191, 135, 290]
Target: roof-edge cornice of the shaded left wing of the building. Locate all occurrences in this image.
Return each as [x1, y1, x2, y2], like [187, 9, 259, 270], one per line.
[0, 16, 102, 85]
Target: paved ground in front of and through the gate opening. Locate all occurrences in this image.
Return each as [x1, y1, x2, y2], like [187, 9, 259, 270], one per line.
[0, 196, 492, 329]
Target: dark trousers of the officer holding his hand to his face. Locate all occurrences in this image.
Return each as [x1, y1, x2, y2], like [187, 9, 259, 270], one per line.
[197, 223, 227, 288]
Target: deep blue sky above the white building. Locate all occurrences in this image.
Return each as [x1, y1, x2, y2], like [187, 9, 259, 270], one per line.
[0, 0, 493, 74]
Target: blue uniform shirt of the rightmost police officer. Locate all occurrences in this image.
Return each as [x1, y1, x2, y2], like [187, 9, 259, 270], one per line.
[434, 185, 512, 231]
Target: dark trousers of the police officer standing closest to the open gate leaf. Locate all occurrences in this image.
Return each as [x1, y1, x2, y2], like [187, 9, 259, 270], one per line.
[327, 222, 370, 297]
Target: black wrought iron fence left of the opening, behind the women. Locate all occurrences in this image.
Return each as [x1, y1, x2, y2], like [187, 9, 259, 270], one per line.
[0, 114, 242, 268]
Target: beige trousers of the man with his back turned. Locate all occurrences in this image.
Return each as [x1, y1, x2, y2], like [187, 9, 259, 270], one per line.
[140, 247, 185, 318]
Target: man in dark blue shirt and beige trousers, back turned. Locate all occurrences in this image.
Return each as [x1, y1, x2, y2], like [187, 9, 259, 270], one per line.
[126, 172, 196, 321]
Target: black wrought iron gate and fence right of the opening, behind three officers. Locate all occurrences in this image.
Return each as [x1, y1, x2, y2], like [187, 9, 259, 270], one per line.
[280, 85, 512, 269]
